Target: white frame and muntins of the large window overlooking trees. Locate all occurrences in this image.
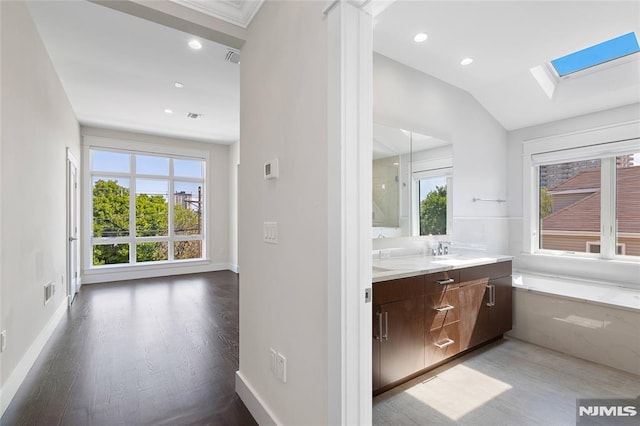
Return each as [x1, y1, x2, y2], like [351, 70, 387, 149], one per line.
[82, 136, 209, 272]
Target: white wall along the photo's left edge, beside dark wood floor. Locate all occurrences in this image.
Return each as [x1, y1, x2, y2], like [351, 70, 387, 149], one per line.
[0, 1, 80, 411]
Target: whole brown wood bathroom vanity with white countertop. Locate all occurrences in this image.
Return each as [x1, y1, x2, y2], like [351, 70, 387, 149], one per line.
[372, 255, 512, 394]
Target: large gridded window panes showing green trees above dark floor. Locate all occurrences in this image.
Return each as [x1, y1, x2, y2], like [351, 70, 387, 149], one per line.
[89, 148, 205, 267]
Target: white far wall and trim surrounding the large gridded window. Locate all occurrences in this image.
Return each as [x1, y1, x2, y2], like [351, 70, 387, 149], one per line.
[82, 127, 230, 284]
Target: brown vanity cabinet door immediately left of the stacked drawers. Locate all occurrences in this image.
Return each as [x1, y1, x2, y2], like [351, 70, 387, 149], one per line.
[380, 297, 424, 387]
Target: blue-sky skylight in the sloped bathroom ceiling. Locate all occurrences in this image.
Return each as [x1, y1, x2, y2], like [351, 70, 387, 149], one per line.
[551, 32, 640, 77]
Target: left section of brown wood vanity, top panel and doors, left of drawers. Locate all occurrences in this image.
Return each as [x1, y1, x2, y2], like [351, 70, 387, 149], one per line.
[372, 276, 424, 390]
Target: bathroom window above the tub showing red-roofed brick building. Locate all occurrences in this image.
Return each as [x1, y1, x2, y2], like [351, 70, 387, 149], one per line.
[537, 150, 640, 258]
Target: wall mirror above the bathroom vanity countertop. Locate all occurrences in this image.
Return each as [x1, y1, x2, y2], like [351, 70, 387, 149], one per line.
[372, 124, 453, 238]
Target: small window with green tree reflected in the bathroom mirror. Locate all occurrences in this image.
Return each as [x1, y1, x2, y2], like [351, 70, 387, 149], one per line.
[412, 168, 452, 235]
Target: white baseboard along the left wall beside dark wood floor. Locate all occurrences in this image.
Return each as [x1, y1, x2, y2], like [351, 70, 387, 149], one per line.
[0, 297, 69, 417]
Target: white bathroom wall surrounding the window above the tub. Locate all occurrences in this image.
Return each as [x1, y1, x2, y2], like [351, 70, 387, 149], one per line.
[507, 104, 640, 285]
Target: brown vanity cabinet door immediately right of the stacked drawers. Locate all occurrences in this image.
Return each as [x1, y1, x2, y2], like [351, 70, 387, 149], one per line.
[458, 280, 490, 351]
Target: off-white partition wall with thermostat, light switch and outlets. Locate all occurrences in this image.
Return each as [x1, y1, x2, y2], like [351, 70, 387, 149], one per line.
[237, 1, 330, 425]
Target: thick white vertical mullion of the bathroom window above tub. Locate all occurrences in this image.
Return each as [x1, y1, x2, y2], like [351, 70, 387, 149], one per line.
[600, 157, 616, 259]
